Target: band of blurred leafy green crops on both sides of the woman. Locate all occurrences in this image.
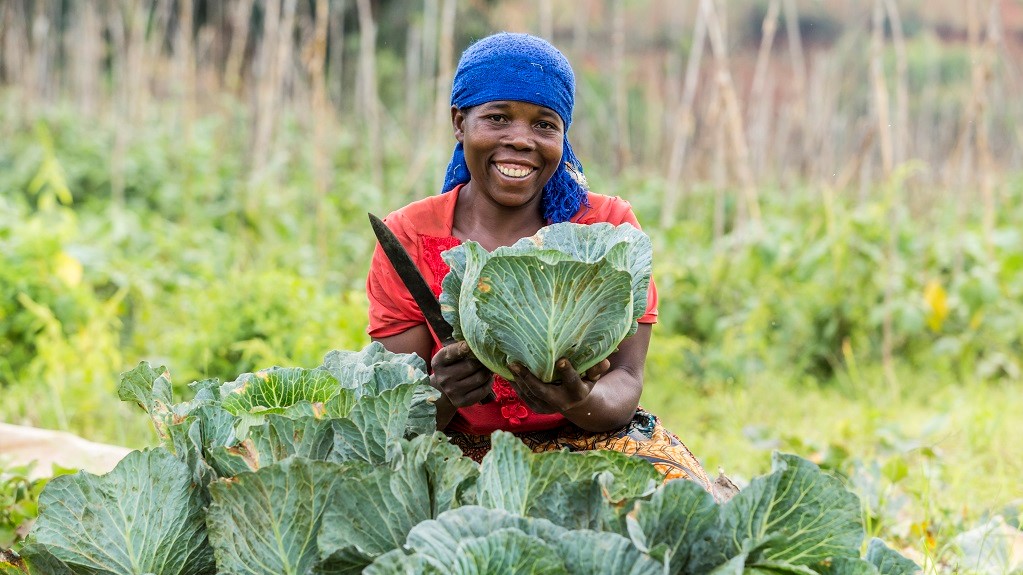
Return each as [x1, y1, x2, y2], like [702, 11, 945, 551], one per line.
[0, 94, 1023, 443]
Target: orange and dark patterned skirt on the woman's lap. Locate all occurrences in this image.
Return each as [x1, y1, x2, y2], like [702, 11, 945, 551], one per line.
[446, 408, 739, 501]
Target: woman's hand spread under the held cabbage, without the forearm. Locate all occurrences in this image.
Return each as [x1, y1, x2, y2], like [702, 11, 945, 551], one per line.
[508, 358, 611, 413]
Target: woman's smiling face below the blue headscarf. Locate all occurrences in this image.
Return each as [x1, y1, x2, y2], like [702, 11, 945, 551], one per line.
[451, 100, 565, 208]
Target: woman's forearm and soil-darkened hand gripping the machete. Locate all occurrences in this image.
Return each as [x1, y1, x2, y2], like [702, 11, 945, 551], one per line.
[373, 324, 493, 430]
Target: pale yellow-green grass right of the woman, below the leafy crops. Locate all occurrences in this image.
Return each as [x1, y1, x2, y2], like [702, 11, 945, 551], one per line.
[642, 356, 1023, 563]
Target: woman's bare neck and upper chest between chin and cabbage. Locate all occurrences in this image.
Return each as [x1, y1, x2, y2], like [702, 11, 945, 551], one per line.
[451, 182, 546, 252]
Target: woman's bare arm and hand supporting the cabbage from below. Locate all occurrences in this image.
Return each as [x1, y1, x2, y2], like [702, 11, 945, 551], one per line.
[512, 323, 652, 432]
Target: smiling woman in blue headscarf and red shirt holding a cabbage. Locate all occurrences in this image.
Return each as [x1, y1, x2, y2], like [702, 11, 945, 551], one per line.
[367, 33, 732, 497]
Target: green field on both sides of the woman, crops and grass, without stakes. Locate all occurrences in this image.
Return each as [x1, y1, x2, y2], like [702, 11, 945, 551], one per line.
[0, 95, 1023, 567]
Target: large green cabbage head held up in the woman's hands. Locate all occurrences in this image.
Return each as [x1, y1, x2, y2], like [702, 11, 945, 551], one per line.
[441, 222, 653, 382]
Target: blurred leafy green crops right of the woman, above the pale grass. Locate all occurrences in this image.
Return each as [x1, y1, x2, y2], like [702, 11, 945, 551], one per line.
[624, 168, 1023, 385]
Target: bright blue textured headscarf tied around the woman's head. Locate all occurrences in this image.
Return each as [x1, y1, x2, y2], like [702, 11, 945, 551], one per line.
[441, 33, 586, 223]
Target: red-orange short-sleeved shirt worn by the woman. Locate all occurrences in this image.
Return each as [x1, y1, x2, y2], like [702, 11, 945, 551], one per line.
[366, 186, 657, 435]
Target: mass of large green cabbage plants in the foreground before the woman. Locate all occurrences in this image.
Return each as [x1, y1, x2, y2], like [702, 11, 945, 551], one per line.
[0, 344, 917, 575]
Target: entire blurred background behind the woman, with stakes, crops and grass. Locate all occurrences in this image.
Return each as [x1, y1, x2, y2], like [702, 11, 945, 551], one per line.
[0, 0, 1023, 573]
